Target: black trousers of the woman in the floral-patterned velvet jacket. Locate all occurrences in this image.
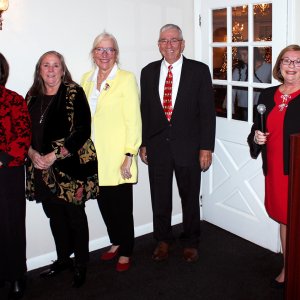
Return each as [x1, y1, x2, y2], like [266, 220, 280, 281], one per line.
[42, 200, 89, 266]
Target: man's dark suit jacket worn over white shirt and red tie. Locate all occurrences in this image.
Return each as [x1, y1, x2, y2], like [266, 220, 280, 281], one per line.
[141, 57, 216, 166]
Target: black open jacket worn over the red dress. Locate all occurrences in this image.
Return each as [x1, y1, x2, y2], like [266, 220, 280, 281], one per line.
[248, 86, 300, 175]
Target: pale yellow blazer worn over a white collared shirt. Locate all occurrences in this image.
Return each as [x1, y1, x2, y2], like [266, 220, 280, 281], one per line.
[81, 69, 142, 186]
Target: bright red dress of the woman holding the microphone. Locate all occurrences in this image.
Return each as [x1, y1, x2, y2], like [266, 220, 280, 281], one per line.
[265, 89, 300, 224]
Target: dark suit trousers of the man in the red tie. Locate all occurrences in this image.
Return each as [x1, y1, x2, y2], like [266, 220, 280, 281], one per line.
[149, 159, 201, 247]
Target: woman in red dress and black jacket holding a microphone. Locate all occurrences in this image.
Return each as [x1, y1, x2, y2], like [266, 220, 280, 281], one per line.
[248, 45, 300, 288]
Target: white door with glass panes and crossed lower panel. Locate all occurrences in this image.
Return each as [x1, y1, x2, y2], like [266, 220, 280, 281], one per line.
[195, 0, 287, 252]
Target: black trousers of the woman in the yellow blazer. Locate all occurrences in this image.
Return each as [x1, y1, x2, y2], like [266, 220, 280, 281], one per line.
[97, 183, 134, 257]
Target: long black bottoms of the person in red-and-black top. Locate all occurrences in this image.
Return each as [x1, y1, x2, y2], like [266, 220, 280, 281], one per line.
[0, 166, 27, 280]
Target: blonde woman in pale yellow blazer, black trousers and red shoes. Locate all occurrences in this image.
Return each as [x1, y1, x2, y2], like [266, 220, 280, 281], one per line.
[81, 32, 141, 271]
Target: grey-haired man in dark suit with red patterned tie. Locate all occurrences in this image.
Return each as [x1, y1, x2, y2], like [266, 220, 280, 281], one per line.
[140, 24, 215, 262]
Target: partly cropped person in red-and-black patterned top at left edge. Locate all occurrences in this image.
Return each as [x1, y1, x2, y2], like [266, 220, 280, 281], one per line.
[0, 53, 31, 299]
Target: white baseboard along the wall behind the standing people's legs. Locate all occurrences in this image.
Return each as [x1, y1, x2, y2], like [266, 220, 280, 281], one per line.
[27, 214, 182, 271]
